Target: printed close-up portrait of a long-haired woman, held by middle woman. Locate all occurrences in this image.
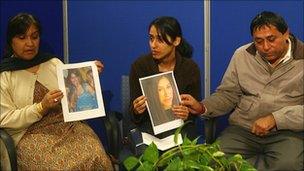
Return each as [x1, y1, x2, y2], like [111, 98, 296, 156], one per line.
[139, 71, 184, 135]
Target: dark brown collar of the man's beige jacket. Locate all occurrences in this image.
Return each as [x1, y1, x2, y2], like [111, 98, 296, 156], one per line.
[246, 34, 304, 60]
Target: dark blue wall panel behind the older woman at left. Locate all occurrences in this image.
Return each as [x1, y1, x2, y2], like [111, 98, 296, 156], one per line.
[0, 0, 63, 59]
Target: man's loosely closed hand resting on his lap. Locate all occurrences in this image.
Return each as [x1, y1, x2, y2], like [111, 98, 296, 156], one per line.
[251, 114, 276, 136]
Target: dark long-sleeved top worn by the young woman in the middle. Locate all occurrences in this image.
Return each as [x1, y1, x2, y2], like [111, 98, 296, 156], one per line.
[129, 53, 201, 138]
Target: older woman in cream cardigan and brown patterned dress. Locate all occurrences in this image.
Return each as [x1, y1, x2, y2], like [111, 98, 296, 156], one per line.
[0, 13, 113, 170]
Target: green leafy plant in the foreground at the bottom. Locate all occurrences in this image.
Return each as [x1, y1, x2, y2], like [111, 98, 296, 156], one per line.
[123, 122, 256, 171]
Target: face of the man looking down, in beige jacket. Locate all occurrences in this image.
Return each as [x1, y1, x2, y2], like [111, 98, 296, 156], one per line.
[253, 25, 289, 63]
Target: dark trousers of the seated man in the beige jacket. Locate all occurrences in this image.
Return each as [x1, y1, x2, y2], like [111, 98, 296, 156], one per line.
[218, 126, 304, 171]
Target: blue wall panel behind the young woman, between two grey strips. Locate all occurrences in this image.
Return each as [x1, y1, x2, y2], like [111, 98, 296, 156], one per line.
[68, 1, 203, 111]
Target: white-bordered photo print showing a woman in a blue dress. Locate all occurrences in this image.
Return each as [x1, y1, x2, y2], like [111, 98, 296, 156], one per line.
[57, 62, 106, 122]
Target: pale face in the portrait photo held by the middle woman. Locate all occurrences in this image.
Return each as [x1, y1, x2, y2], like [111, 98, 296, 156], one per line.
[157, 77, 173, 110]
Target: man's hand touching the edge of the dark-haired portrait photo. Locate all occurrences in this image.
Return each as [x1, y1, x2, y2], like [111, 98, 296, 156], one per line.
[180, 94, 205, 114]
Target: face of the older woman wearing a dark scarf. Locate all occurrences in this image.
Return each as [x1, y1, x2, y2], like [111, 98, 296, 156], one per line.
[11, 25, 40, 60]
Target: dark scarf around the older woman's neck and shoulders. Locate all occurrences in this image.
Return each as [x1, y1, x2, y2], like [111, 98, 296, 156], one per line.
[0, 52, 55, 73]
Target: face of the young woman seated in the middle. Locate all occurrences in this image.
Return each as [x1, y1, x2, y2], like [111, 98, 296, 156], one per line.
[149, 26, 175, 60]
